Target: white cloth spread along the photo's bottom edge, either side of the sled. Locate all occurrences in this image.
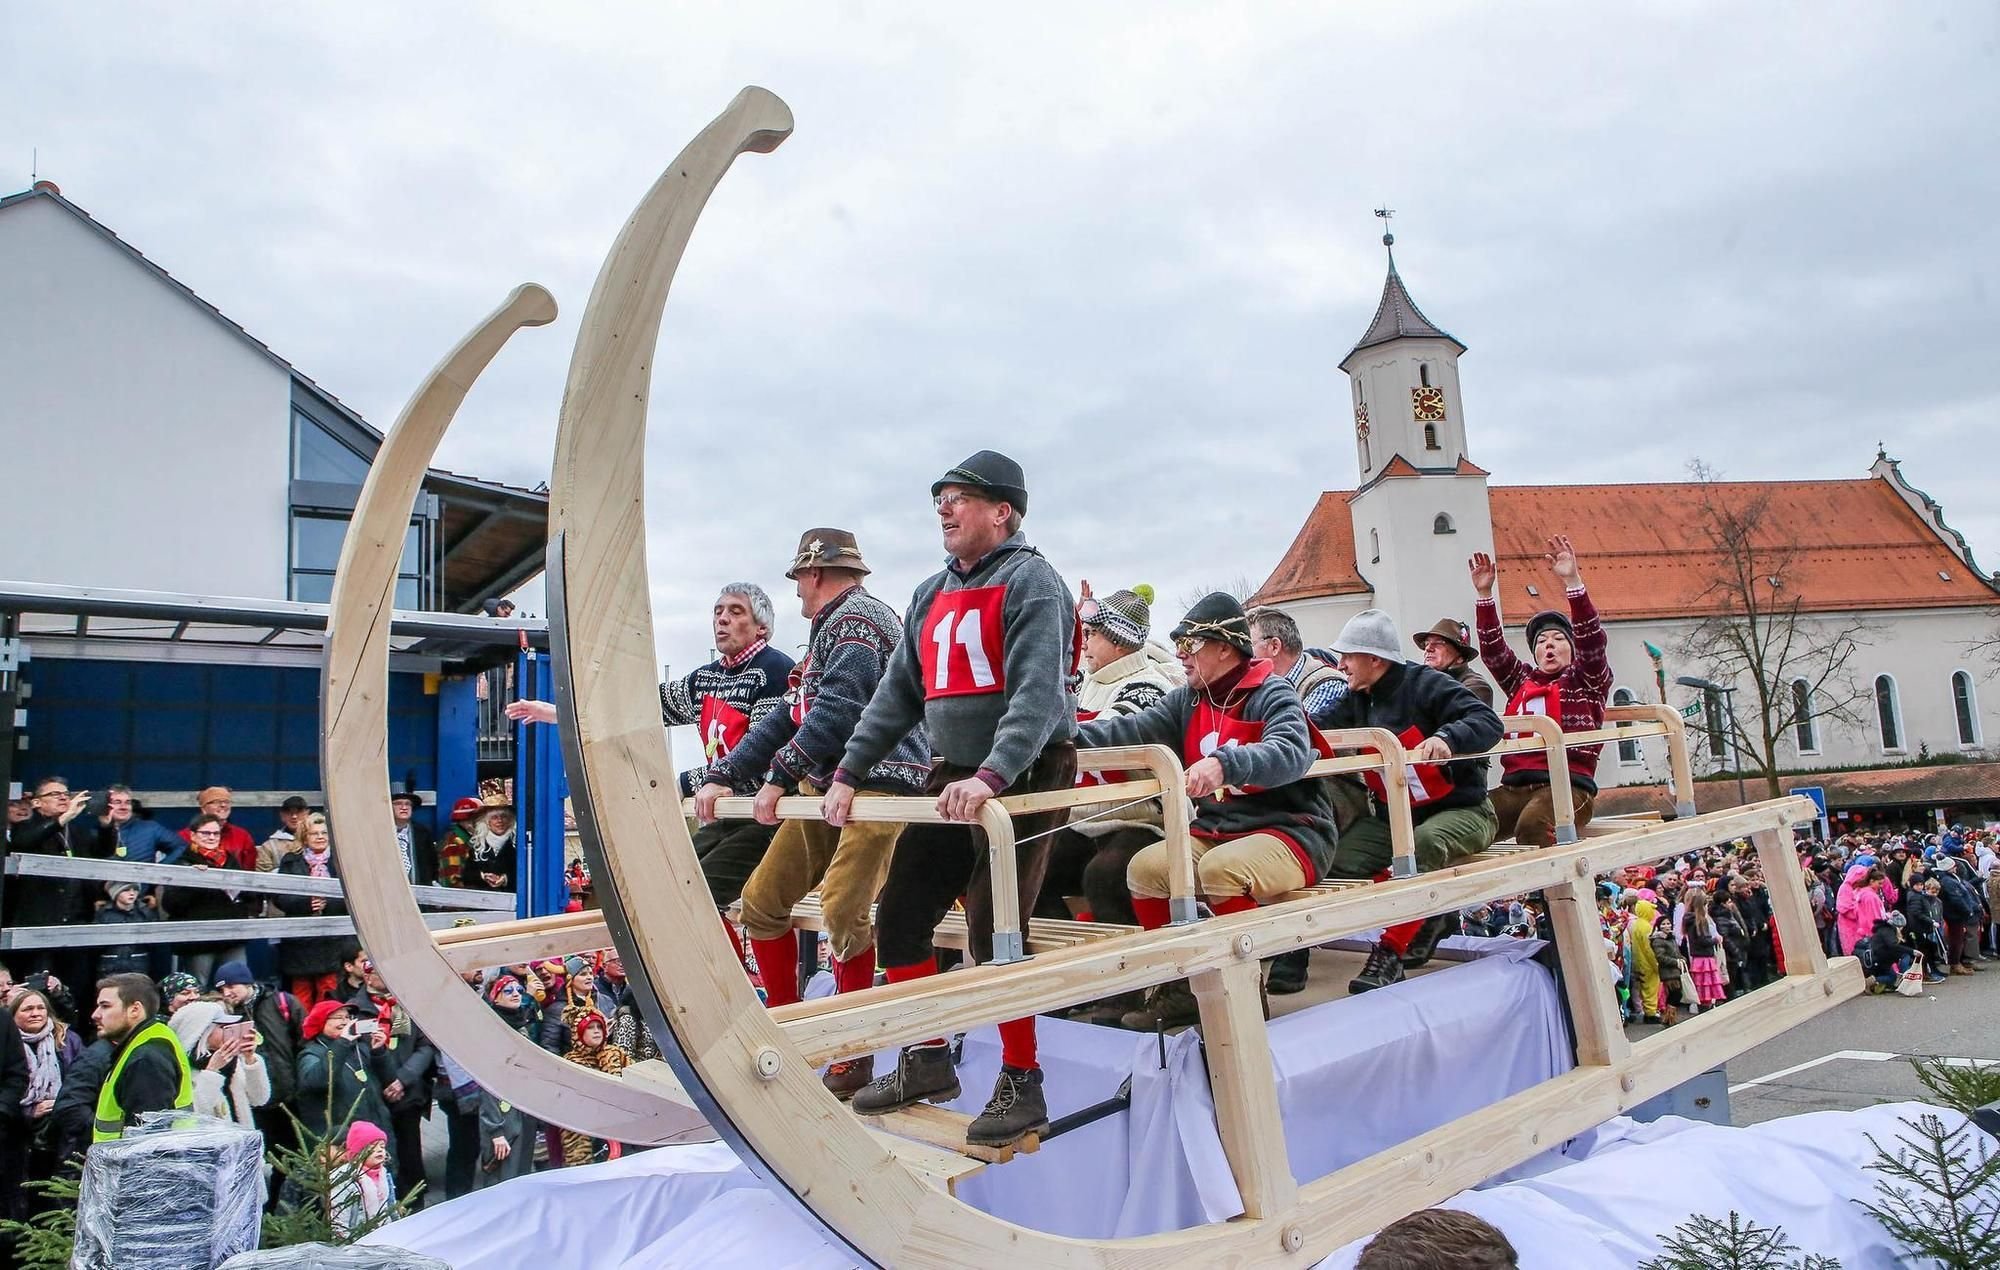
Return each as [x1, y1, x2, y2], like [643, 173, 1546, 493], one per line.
[376, 1102, 1992, 1270]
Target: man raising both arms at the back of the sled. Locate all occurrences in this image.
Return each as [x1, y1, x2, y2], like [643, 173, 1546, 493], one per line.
[1468, 534, 1612, 846]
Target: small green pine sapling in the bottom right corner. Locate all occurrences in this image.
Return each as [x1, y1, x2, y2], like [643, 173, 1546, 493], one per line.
[1856, 1114, 2000, 1270]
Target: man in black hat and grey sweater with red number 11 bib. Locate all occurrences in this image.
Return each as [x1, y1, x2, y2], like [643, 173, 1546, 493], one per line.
[824, 450, 1076, 1146]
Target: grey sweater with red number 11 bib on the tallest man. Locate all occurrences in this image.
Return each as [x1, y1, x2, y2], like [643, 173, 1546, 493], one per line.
[834, 534, 1076, 786]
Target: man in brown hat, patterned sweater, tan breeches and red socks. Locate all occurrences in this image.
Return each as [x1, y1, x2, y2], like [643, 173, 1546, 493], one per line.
[694, 530, 930, 1098]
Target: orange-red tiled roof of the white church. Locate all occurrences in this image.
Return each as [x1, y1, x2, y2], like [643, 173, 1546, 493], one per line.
[1258, 476, 1996, 620]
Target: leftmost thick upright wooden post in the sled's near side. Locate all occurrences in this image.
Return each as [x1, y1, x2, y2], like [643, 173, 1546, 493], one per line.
[1190, 958, 1298, 1218]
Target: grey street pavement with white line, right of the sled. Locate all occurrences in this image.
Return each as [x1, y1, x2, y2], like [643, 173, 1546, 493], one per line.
[1626, 960, 2000, 1124]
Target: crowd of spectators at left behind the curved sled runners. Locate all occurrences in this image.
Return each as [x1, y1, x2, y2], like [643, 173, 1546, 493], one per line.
[0, 776, 608, 1222]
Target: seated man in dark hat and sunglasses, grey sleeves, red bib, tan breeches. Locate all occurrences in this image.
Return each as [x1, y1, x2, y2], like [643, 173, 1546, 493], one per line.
[1078, 592, 1336, 1030]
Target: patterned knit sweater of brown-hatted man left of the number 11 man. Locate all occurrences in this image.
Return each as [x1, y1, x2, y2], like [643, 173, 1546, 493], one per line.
[708, 586, 930, 794]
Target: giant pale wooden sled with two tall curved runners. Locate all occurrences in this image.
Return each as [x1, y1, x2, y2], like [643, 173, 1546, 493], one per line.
[326, 88, 1862, 1268]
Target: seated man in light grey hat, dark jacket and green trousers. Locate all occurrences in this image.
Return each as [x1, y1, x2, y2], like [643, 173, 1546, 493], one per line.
[1326, 608, 1500, 992]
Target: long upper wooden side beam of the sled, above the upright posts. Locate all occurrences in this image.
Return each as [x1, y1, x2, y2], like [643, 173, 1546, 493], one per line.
[770, 798, 1814, 1064]
